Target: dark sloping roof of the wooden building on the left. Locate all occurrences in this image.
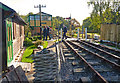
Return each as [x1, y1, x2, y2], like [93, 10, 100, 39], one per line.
[0, 2, 26, 25]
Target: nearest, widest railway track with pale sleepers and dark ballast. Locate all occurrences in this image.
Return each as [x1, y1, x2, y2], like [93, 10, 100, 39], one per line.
[63, 41, 120, 83]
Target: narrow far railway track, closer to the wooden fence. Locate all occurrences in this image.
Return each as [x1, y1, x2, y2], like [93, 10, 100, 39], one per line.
[72, 41, 120, 65]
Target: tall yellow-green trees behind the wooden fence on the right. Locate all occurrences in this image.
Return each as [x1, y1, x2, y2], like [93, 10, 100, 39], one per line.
[82, 0, 120, 33]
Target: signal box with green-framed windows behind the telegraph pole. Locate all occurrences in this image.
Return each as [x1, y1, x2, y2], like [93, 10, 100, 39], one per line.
[28, 12, 52, 35]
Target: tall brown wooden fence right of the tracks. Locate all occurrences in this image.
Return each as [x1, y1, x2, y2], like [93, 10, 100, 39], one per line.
[100, 24, 120, 42]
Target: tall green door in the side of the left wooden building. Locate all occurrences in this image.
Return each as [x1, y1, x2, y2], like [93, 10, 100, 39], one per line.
[6, 19, 13, 64]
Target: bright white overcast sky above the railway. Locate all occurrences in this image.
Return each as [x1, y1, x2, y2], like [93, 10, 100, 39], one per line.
[0, 0, 92, 24]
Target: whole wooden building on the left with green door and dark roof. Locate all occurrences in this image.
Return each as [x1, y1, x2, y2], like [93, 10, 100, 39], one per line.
[0, 2, 26, 70]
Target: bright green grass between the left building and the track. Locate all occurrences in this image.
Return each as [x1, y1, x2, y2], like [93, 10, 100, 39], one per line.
[21, 41, 48, 63]
